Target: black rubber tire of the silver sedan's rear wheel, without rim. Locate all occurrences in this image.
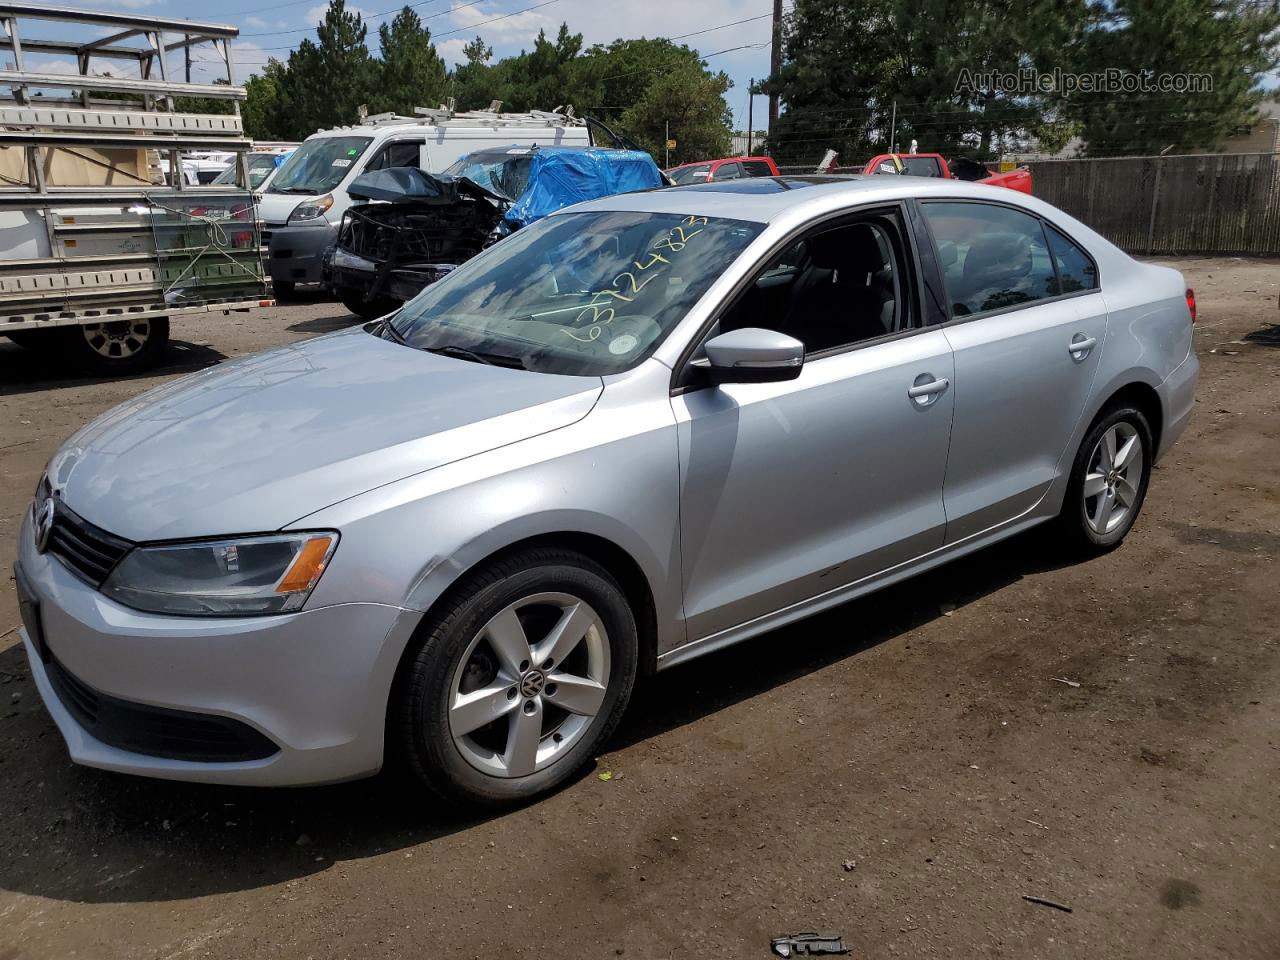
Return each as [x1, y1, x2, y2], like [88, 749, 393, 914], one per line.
[1059, 404, 1156, 554]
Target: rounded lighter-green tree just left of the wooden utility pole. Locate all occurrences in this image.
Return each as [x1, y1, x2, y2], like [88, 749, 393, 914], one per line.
[620, 63, 733, 165]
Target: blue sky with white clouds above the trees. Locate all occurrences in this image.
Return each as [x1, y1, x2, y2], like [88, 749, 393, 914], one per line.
[28, 0, 791, 129]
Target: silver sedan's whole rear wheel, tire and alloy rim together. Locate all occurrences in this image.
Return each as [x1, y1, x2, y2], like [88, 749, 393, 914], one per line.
[1060, 406, 1155, 553]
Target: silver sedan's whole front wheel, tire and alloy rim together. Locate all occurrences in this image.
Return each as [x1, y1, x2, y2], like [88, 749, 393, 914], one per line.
[389, 549, 637, 806]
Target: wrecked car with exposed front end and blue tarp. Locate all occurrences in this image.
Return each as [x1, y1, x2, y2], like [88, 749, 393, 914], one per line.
[324, 146, 666, 319]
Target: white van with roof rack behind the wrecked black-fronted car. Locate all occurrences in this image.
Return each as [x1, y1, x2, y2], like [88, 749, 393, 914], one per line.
[257, 109, 591, 297]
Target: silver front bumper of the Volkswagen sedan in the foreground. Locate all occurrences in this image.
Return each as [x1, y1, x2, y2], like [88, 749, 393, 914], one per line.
[18, 512, 421, 786]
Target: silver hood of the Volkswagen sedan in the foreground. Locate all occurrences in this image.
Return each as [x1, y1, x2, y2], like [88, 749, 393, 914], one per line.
[49, 328, 603, 540]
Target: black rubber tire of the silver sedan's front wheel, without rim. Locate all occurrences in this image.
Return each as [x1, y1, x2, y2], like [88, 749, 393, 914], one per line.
[388, 548, 637, 808]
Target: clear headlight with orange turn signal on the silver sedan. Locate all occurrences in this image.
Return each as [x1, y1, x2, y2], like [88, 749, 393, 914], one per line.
[102, 531, 338, 617]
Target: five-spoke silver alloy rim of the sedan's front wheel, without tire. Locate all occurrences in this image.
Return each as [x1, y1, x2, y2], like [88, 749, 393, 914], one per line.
[448, 593, 611, 778]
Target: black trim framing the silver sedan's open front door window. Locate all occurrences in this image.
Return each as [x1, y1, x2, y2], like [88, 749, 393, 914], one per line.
[671, 198, 938, 397]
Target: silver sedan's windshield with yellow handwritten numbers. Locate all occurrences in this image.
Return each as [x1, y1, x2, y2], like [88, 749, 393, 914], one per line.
[390, 211, 763, 376]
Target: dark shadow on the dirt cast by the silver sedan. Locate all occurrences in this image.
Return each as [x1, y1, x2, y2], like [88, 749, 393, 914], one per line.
[0, 531, 1069, 902]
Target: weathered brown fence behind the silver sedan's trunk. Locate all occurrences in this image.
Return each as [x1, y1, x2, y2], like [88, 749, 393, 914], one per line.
[1028, 154, 1280, 256]
